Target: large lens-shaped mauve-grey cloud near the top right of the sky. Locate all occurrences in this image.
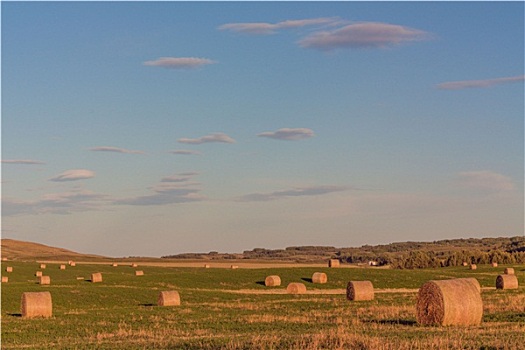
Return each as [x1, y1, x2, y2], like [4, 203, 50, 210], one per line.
[298, 22, 429, 51]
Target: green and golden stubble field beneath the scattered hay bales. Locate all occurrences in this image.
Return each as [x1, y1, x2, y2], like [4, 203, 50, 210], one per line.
[1, 262, 525, 350]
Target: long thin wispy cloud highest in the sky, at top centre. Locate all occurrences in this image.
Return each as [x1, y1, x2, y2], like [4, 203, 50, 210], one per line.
[218, 17, 340, 35]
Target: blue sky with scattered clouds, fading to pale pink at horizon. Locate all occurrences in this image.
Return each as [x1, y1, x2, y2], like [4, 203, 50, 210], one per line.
[1, 2, 524, 256]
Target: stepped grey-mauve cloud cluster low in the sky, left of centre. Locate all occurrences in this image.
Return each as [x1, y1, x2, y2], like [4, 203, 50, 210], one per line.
[113, 173, 206, 206]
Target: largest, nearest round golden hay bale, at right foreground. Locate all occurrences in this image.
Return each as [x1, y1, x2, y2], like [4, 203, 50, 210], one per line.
[416, 278, 483, 326]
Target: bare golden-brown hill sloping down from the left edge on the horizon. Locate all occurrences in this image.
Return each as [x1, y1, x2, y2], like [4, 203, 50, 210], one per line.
[1, 238, 105, 260]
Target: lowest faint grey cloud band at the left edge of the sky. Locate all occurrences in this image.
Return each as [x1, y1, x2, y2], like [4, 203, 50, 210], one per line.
[2, 190, 108, 216]
